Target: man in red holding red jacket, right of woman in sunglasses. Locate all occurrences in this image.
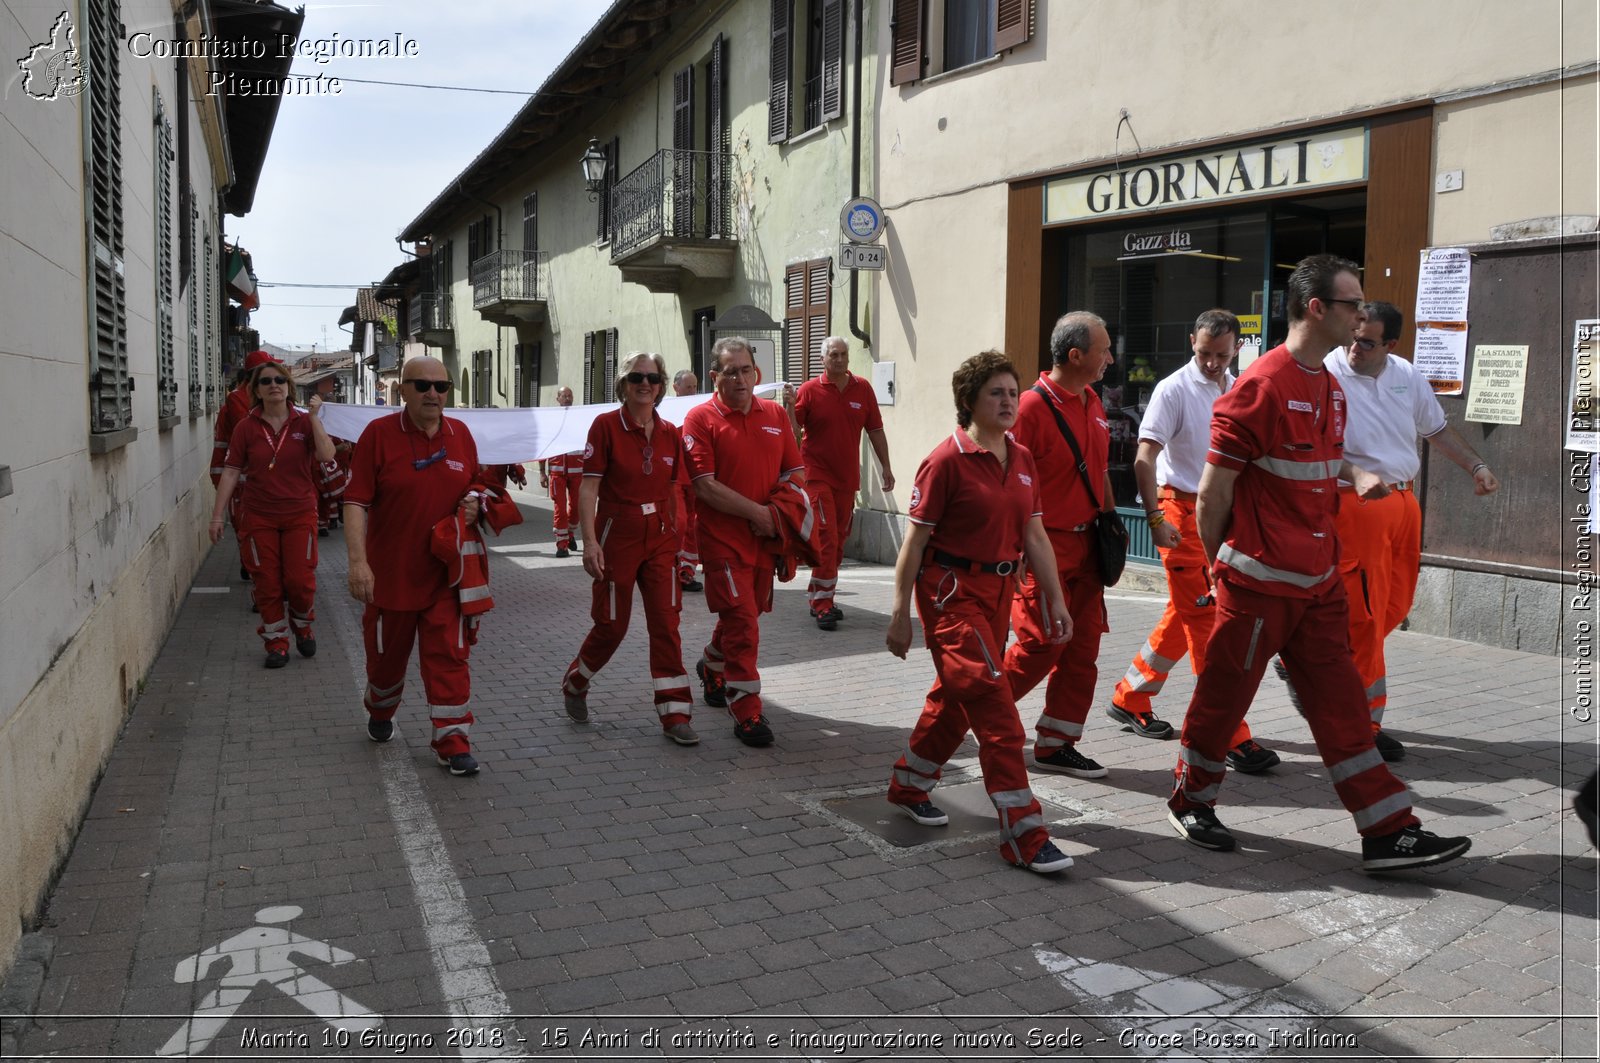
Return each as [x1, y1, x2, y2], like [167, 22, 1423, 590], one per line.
[683, 336, 805, 746]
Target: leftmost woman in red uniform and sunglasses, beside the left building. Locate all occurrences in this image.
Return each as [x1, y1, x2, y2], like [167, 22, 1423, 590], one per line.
[211, 362, 333, 668]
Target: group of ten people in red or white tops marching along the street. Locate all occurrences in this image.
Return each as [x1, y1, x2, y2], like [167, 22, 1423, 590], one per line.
[211, 255, 1499, 872]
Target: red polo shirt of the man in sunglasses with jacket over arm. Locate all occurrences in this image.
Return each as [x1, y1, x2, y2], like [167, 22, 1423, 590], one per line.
[344, 410, 478, 612]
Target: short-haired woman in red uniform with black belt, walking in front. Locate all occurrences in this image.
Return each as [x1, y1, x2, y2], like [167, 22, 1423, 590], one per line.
[886, 351, 1072, 874]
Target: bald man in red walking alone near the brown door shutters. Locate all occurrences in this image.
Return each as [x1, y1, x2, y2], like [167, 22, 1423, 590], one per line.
[794, 336, 894, 631]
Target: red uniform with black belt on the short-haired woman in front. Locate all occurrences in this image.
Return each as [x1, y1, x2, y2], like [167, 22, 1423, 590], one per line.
[888, 431, 1050, 864]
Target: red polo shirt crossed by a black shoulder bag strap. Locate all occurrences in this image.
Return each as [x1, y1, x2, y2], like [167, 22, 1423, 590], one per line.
[1011, 373, 1110, 532]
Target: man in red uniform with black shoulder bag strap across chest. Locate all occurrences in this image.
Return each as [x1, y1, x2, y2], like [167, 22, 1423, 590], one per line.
[1005, 311, 1115, 778]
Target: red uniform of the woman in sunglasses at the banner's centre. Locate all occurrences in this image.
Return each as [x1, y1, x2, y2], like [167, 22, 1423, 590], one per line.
[562, 407, 693, 728]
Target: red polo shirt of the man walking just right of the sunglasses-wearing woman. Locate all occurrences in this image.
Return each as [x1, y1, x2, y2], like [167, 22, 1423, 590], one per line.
[683, 395, 805, 565]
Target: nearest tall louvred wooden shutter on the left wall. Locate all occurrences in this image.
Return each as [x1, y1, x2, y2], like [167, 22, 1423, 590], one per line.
[85, 0, 133, 432]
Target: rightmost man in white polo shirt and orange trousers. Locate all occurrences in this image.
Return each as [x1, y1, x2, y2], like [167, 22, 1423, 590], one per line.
[1296, 301, 1499, 760]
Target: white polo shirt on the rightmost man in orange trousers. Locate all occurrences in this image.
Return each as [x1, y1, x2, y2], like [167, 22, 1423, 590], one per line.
[1323, 347, 1445, 483]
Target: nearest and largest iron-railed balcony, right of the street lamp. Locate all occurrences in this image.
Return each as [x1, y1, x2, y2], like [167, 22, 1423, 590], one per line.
[611, 147, 738, 291]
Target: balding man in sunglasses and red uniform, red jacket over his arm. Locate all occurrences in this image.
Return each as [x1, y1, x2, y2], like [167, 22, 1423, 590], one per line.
[353, 359, 478, 775]
